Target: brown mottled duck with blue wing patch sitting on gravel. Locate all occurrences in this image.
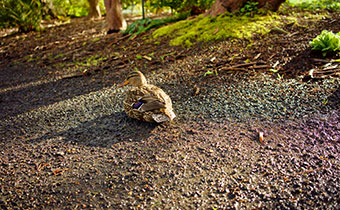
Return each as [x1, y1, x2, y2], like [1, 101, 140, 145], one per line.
[118, 70, 176, 123]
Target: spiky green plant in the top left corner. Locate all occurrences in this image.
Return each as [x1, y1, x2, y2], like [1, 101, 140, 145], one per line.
[0, 0, 42, 32]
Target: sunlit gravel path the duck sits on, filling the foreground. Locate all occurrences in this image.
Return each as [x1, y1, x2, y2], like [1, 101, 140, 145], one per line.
[0, 54, 340, 209]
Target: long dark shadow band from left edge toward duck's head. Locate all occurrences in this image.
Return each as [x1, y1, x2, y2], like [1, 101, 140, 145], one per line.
[0, 68, 123, 118]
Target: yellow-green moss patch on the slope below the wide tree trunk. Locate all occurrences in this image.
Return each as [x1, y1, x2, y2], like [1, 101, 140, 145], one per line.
[152, 14, 292, 46]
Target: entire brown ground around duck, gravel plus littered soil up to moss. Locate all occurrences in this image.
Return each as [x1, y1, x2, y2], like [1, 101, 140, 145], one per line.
[0, 7, 340, 209]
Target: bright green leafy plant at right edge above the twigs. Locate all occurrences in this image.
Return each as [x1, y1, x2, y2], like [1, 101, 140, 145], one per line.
[309, 30, 340, 56]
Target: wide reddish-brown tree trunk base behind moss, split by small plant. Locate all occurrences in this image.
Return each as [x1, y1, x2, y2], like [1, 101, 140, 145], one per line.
[205, 0, 285, 16]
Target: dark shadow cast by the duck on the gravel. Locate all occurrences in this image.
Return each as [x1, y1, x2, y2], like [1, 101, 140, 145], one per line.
[27, 111, 158, 147]
